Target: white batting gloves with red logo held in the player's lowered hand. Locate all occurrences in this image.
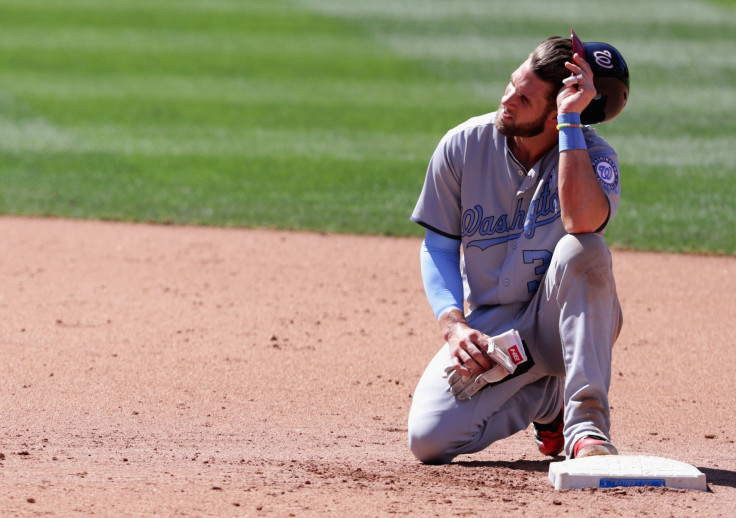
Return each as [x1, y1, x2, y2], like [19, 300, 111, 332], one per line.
[445, 329, 527, 401]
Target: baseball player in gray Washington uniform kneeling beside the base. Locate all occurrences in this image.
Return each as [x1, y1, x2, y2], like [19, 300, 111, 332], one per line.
[408, 33, 629, 464]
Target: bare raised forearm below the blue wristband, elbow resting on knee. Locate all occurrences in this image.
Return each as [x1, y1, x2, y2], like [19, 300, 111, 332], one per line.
[558, 149, 609, 234]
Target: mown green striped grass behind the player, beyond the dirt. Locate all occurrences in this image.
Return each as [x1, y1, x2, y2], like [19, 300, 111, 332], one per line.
[0, 0, 736, 254]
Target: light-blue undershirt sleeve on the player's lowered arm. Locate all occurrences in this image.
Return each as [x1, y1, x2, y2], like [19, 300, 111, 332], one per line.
[420, 229, 463, 319]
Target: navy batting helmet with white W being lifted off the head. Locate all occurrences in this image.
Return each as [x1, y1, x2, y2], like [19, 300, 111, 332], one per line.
[570, 31, 629, 124]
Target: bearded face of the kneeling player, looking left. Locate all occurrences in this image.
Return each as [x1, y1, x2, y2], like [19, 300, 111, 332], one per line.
[494, 61, 553, 137]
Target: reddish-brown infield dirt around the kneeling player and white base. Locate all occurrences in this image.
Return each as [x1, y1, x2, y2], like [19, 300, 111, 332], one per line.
[0, 218, 736, 518]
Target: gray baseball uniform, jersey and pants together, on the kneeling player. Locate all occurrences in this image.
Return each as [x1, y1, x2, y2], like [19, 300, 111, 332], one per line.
[408, 113, 622, 463]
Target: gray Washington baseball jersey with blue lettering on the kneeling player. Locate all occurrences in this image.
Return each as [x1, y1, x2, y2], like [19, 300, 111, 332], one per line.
[411, 113, 620, 308]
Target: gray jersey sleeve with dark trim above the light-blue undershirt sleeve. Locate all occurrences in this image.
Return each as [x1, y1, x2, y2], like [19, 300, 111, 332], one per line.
[411, 133, 462, 239]
